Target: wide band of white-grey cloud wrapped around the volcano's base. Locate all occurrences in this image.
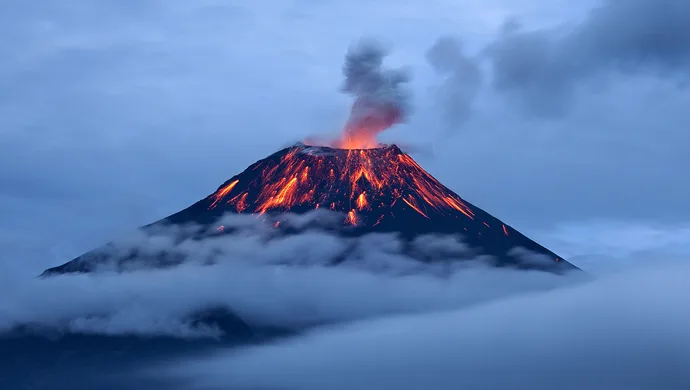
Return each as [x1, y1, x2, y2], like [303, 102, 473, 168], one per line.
[0, 216, 586, 337]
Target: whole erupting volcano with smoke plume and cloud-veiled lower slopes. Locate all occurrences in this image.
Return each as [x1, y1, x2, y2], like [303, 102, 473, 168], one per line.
[44, 40, 576, 275]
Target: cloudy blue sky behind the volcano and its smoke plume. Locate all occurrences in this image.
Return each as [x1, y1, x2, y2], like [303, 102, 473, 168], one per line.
[0, 0, 690, 272]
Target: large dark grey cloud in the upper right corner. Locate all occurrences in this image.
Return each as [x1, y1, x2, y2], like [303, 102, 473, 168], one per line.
[486, 0, 690, 117]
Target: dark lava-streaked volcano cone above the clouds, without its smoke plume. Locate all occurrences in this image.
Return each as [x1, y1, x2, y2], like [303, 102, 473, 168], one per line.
[43, 143, 577, 275]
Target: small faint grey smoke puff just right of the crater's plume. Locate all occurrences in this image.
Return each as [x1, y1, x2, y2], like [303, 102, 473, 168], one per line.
[426, 37, 483, 127]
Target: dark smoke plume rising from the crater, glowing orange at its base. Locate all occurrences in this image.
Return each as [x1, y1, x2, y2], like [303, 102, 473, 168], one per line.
[334, 40, 410, 148]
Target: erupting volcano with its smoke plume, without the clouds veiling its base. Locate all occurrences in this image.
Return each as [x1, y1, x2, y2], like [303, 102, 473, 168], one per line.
[39, 44, 576, 274]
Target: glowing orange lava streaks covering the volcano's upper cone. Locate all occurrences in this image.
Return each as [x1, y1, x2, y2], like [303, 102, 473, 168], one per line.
[202, 145, 475, 225]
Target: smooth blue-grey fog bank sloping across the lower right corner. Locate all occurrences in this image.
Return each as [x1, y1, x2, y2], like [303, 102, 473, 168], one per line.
[167, 263, 690, 390]
